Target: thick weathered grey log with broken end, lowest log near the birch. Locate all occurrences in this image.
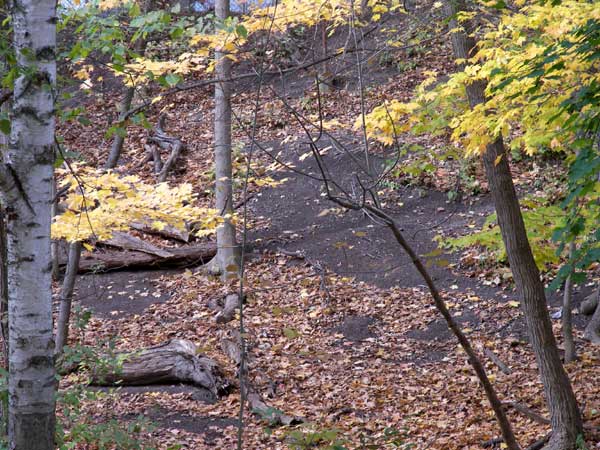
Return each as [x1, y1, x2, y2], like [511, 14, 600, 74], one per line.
[71, 339, 230, 396]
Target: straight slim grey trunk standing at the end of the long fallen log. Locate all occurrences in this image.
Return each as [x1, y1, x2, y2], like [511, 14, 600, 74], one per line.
[214, 0, 240, 279]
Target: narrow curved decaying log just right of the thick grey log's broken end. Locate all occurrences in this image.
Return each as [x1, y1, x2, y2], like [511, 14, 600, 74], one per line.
[221, 333, 303, 426]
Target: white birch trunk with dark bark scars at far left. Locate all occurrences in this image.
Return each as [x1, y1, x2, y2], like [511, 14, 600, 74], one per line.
[0, 0, 57, 450]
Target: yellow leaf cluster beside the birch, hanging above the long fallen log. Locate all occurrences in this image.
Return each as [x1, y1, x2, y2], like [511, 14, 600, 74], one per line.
[52, 166, 223, 242]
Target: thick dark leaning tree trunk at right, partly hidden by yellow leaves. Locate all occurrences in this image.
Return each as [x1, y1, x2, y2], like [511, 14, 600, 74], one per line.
[446, 0, 583, 450]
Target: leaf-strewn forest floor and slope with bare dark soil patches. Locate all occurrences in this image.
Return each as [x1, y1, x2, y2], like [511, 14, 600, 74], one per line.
[57, 4, 600, 450]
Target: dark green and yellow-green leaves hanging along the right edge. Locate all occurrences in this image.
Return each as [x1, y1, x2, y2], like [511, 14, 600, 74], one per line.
[503, 17, 600, 289]
